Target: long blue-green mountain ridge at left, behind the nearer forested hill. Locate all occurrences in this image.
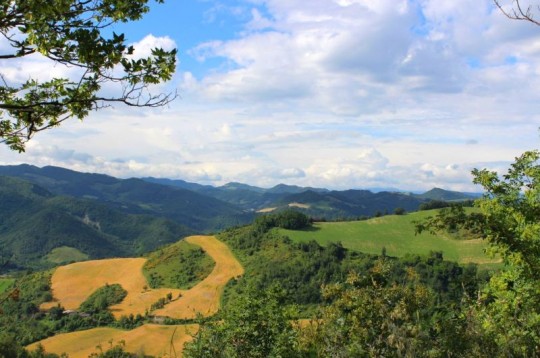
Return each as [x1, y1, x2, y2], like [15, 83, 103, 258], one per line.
[0, 165, 252, 231]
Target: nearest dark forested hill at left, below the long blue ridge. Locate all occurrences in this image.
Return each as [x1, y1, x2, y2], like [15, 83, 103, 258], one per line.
[0, 176, 193, 269]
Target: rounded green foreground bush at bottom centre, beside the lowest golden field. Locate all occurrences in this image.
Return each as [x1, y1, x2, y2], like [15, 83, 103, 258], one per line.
[183, 289, 297, 358]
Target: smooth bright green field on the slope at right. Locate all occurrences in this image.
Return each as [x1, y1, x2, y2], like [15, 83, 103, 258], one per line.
[282, 210, 497, 264]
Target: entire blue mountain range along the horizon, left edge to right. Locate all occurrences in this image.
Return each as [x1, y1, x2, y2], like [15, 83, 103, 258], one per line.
[0, 165, 471, 232]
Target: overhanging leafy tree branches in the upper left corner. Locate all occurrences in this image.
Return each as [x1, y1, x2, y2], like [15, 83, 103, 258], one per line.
[0, 0, 176, 151]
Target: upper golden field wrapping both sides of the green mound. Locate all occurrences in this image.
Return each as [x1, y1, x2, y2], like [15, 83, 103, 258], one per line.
[41, 236, 244, 318]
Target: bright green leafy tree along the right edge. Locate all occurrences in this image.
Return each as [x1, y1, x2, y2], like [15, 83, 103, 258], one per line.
[473, 151, 540, 356]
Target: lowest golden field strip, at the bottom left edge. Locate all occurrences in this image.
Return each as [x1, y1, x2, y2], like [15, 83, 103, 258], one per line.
[28, 324, 198, 358]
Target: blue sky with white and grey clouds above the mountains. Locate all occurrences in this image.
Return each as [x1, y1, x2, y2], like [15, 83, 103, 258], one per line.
[0, 0, 540, 191]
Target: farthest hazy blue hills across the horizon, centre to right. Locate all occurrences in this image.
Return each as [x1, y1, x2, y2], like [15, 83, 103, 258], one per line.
[143, 178, 478, 220]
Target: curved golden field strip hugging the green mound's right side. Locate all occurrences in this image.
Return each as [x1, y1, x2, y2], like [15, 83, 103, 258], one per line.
[154, 236, 244, 318]
